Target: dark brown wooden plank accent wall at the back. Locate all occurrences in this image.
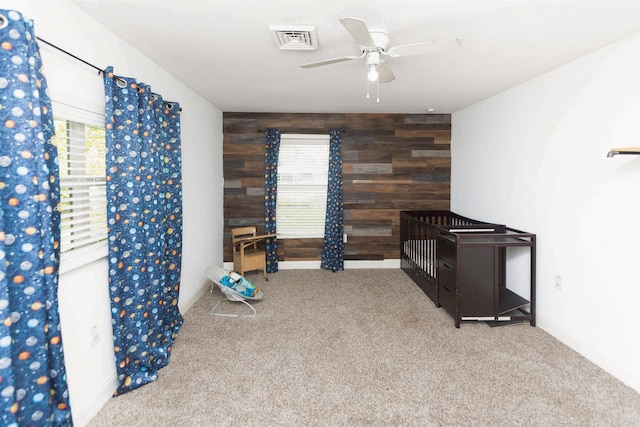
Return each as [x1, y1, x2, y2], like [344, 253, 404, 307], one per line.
[223, 113, 451, 262]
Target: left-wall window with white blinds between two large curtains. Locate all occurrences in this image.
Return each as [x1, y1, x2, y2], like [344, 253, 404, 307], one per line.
[53, 104, 107, 270]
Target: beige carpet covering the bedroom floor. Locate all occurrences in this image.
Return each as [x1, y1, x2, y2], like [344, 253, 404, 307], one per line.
[89, 269, 640, 427]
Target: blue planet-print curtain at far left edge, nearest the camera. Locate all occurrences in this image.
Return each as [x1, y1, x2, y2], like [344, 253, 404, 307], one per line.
[0, 9, 72, 427]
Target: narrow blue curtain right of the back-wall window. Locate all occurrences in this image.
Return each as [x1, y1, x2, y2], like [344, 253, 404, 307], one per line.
[320, 129, 344, 272]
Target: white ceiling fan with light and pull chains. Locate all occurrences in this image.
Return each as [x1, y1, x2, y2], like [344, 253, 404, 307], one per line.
[301, 18, 460, 102]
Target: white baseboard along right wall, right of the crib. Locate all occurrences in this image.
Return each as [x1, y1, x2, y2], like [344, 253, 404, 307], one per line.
[536, 314, 640, 392]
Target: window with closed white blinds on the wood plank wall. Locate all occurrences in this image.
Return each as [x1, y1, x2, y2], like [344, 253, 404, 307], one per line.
[276, 134, 329, 239]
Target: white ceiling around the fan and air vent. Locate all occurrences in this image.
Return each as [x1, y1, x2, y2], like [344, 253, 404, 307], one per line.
[73, 0, 640, 113]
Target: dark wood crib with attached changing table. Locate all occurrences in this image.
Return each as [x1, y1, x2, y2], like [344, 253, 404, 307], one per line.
[400, 210, 536, 327]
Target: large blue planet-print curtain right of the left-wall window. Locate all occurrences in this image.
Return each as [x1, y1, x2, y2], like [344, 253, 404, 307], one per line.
[104, 67, 182, 395]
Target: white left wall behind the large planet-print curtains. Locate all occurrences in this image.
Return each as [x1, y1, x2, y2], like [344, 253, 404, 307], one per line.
[1, 0, 223, 426]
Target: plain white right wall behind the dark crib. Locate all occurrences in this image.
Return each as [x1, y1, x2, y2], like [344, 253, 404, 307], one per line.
[451, 34, 640, 391]
